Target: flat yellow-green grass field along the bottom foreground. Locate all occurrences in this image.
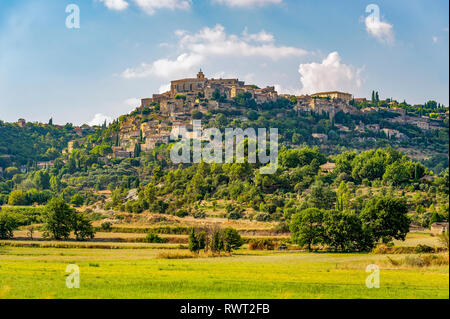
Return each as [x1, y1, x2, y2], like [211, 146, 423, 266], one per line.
[0, 246, 449, 299]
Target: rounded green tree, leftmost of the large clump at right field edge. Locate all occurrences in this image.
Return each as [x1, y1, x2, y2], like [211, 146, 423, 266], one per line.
[289, 208, 323, 250]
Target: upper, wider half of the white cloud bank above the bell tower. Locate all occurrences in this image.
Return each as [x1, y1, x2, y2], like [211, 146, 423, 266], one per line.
[180, 24, 307, 60]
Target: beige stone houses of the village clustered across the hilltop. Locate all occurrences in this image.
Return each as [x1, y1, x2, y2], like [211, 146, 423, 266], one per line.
[92, 70, 448, 158]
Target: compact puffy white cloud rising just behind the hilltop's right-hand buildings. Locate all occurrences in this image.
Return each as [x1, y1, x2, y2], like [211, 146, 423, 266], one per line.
[298, 52, 362, 94]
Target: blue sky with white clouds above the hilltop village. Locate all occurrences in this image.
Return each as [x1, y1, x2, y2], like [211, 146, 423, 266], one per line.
[0, 0, 449, 124]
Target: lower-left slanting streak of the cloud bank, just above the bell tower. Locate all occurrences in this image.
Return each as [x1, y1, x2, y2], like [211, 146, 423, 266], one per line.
[122, 53, 203, 79]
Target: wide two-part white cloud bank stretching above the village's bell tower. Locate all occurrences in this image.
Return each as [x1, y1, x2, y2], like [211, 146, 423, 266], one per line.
[122, 24, 307, 79]
